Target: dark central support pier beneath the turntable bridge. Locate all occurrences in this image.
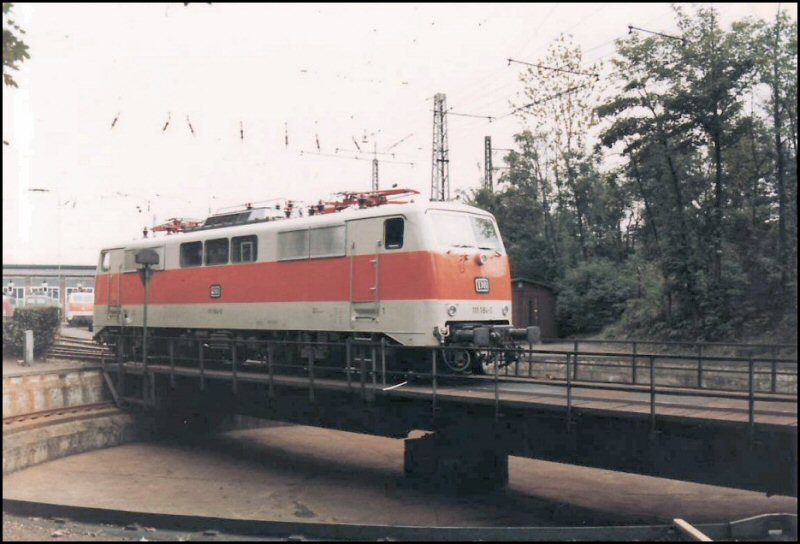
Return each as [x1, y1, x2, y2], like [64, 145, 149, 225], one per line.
[404, 431, 508, 492]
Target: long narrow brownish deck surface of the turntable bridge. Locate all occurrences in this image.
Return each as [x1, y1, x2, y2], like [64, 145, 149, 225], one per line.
[107, 362, 797, 428]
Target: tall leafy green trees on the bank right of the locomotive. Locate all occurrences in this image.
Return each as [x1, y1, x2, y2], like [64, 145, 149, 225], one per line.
[472, 5, 797, 342]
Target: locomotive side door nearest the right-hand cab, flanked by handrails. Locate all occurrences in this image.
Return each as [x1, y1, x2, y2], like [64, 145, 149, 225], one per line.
[347, 218, 383, 323]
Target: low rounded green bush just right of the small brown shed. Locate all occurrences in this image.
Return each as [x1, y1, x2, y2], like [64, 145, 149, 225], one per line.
[556, 259, 635, 335]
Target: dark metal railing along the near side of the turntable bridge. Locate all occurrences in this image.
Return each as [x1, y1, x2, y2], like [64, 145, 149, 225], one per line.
[101, 334, 797, 436]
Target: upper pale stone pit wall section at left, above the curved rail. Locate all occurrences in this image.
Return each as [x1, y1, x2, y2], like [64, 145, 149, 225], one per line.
[3, 369, 111, 417]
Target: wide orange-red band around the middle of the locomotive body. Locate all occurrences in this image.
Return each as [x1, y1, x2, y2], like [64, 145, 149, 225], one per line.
[95, 252, 511, 306]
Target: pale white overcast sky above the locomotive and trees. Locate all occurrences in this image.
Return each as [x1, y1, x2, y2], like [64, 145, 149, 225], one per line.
[3, 3, 797, 265]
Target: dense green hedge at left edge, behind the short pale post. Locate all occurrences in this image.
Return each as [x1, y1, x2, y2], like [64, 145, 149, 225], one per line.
[3, 307, 61, 357]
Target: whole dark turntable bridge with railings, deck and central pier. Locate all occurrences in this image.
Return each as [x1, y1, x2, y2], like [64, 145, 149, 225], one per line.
[97, 338, 797, 496]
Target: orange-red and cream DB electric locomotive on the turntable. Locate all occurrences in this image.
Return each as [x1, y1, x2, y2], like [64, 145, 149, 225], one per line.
[94, 190, 525, 370]
